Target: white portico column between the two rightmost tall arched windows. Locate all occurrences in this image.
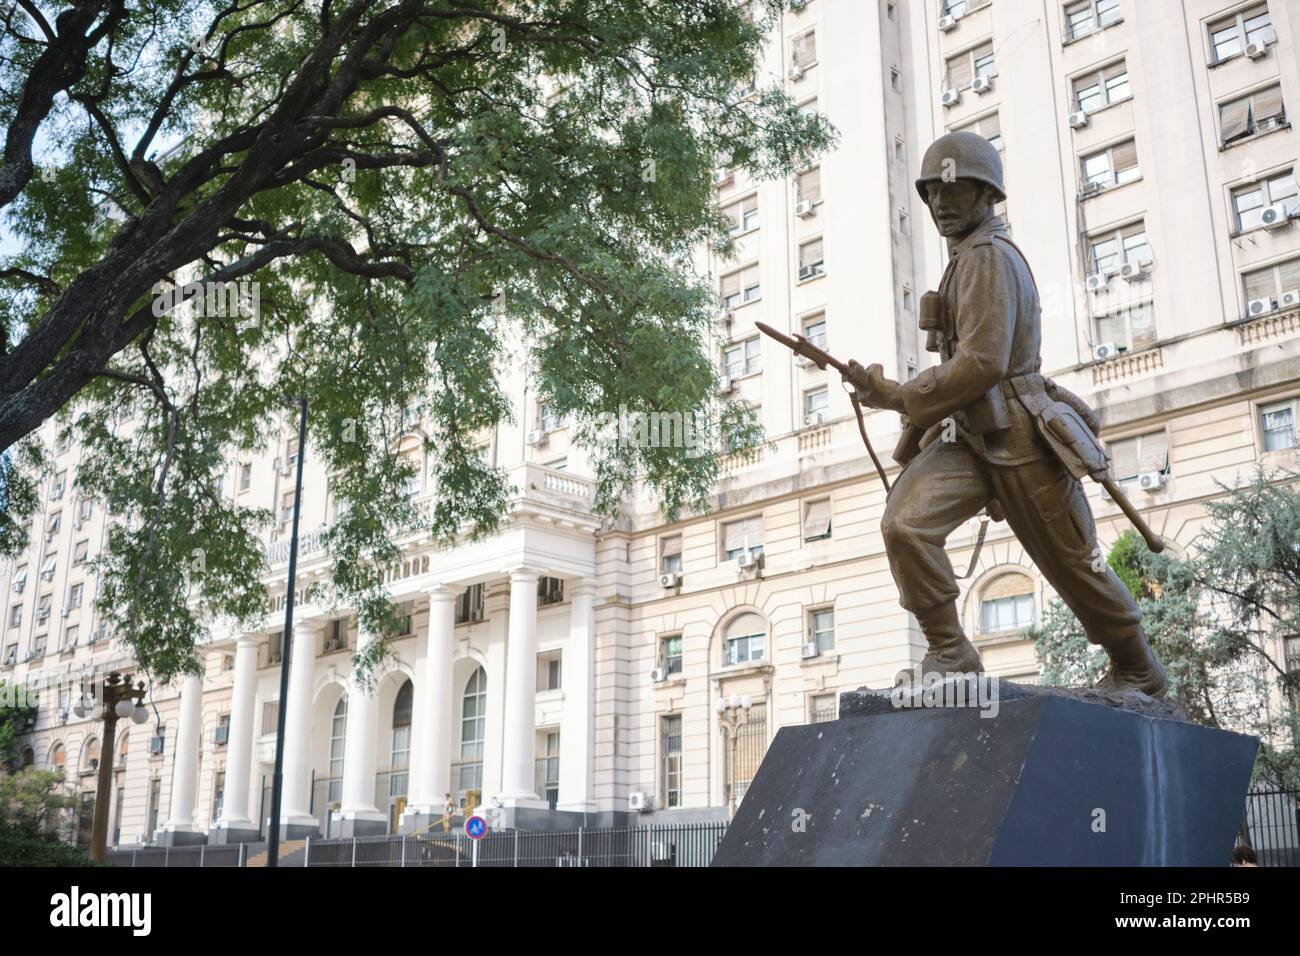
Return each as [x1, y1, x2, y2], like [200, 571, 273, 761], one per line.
[408, 587, 460, 814]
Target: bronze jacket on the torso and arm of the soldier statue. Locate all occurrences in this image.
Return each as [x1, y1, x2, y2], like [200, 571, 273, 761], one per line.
[900, 216, 1050, 464]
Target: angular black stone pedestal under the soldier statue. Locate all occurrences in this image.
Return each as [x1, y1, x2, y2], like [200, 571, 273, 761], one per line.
[712, 684, 1258, 866]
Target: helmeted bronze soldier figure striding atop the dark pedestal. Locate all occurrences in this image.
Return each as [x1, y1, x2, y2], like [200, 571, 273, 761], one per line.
[849, 133, 1166, 697]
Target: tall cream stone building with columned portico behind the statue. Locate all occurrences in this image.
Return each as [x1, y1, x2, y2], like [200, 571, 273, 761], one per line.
[0, 0, 1300, 844]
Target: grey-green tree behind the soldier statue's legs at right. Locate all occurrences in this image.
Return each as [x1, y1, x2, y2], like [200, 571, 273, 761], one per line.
[1032, 470, 1300, 787]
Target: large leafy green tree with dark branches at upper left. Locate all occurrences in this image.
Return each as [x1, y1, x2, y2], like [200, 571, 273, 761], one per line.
[0, 0, 833, 680]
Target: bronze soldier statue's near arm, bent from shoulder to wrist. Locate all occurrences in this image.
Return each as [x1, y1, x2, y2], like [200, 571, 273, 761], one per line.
[897, 245, 1015, 428]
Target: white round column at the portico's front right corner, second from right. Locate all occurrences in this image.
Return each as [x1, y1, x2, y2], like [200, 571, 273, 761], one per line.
[501, 570, 541, 805]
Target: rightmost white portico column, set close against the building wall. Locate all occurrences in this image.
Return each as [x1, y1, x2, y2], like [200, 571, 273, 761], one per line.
[556, 580, 595, 813]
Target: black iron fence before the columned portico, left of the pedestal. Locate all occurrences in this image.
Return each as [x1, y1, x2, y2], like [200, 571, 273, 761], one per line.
[108, 822, 727, 868]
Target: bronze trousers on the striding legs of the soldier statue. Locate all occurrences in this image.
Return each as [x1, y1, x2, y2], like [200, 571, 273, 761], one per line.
[880, 441, 1141, 644]
